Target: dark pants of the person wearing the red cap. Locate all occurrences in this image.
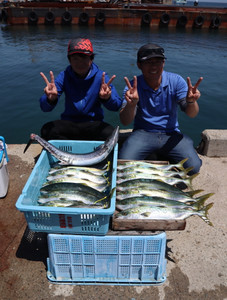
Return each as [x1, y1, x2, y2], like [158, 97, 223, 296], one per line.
[41, 120, 114, 141]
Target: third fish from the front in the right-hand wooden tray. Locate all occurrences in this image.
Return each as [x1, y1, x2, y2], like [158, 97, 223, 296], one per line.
[117, 172, 198, 189]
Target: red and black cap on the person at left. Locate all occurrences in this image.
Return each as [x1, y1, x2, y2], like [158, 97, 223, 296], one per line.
[68, 38, 93, 56]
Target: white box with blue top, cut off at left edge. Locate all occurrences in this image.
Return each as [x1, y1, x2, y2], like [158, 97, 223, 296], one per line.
[0, 136, 9, 198]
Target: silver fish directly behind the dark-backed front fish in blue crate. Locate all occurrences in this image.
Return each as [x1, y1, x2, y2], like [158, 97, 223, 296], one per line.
[43, 176, 110, 192]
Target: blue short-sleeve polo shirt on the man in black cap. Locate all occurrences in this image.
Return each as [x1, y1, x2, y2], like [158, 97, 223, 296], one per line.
[123, 71, 188, 132]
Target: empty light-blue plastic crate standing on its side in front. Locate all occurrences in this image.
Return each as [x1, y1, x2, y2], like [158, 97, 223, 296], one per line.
[47, 232, 166, 285]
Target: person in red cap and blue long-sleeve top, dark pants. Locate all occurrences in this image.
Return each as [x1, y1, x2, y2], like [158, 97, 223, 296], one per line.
[40, 38, 122, 140]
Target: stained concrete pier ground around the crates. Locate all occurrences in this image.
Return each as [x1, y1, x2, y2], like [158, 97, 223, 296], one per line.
[0, 135, 227, 300]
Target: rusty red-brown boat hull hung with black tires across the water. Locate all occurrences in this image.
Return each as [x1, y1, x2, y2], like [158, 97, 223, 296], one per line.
[2, 0, 227, 29]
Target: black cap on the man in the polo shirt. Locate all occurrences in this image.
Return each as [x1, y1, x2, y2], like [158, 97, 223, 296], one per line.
[137, 44, 166, 62]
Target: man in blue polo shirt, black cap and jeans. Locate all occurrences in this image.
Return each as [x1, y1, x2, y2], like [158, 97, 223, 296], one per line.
[119, 44, 203, 175]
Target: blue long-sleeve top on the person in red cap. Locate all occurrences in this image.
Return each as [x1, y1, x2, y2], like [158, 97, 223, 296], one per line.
[40, 63, 122, 122]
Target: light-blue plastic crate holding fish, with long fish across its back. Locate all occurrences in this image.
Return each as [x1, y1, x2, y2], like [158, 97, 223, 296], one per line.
[16, 140, 118, 235]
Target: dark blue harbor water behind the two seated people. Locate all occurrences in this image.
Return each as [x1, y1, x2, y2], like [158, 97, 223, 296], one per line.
[0, 24, 227, 146]
